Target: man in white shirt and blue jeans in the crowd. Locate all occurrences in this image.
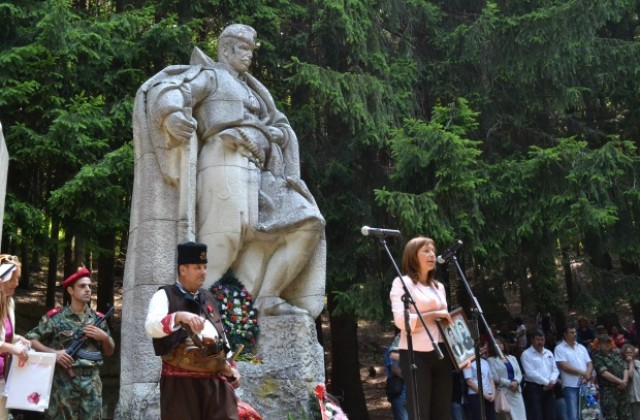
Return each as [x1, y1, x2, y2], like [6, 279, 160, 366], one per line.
[554, 324, 593, 420]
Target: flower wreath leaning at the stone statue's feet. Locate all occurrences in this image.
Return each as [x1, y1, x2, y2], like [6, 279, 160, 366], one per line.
[211, 270, 260, 353]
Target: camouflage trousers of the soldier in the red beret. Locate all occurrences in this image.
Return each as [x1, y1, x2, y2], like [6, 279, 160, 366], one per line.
[45, 366, 102, 420]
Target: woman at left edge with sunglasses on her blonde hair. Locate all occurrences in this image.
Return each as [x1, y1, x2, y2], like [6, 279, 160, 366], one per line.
[0, 255, 31, 420]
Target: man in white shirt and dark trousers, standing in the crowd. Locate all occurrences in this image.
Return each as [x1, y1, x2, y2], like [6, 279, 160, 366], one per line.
[520, 329, 560, 420]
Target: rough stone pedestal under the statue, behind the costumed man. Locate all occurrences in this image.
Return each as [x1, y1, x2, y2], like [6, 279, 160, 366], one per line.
[115, 315, 325, 420]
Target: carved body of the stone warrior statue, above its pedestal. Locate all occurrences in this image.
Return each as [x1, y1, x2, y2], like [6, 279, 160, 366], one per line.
[136, 24, 325, 318]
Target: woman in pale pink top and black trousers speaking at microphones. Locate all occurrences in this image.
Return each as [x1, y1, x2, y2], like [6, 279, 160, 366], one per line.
[389, 236, 453, 420]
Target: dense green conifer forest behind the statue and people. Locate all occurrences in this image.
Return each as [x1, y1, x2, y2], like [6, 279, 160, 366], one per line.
[0, 0, 640, 418]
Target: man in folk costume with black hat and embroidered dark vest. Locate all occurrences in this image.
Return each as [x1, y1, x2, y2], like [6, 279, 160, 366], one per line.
[145, 242, 240, 420]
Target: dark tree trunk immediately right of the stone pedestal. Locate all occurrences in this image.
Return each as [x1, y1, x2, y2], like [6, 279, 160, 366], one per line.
[328, 293, 369, 420]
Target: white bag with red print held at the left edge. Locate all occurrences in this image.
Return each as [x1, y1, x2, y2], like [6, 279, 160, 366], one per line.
[4, 351, 56, 412]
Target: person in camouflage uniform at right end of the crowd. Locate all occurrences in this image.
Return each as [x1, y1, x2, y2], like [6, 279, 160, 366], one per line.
[593, 334, 631, 420]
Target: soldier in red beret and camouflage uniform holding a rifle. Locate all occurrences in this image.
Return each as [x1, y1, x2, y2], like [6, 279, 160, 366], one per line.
[26, 268, 115, 420]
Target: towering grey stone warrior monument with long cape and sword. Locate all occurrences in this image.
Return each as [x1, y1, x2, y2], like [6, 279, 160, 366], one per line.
[118, 24, 326, 418]
